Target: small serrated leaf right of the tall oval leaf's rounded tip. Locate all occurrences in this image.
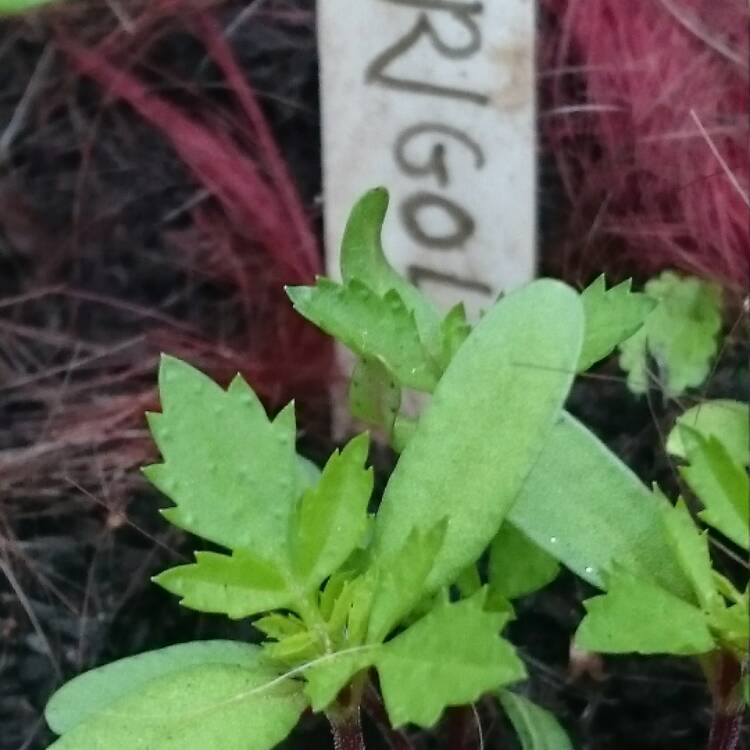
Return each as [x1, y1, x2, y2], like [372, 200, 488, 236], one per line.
[578, 274, 656, 372]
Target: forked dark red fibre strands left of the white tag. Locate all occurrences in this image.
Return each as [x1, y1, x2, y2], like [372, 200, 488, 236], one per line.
[58, 15, 329, 400]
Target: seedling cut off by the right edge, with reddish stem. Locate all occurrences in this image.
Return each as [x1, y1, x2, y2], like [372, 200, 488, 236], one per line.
[576, 401, 750, 748]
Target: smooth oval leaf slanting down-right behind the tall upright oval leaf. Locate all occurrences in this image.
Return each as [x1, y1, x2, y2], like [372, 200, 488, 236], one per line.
[508, 413, 692, 598]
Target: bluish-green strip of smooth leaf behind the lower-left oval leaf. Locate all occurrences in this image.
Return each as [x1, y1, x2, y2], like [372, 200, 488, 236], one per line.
[44, 641, 263, 734]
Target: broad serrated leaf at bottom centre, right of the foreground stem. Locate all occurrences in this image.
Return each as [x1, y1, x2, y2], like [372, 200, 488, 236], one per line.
[375, 599, 526, 727]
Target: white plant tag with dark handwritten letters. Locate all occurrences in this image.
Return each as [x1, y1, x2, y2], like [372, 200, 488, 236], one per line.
[318, 0, 536, 318]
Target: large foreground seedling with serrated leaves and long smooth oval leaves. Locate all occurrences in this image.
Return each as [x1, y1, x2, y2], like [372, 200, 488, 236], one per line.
[42, 195, 584, 750]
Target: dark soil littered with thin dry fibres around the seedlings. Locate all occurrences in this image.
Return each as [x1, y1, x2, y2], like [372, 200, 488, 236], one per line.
[0, 2, 749, 750]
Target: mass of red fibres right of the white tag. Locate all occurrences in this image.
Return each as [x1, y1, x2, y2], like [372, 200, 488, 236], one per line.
[542, 0, 750, 296]
